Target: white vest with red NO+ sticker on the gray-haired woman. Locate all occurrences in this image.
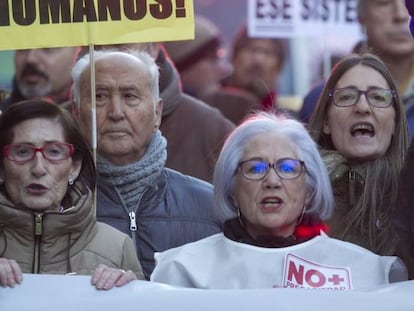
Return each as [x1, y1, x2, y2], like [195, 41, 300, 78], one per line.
[151, 233, 407, 291]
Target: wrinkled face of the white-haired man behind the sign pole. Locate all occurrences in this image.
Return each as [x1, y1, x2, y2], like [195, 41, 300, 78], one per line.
[75, 54, 162, 165]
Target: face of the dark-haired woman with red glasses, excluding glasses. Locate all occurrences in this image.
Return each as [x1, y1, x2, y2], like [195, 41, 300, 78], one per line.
[2, 118, 81, 211]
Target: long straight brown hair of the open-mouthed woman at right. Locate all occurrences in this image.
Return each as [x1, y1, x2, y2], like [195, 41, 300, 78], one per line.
[309, 53, 408, 255]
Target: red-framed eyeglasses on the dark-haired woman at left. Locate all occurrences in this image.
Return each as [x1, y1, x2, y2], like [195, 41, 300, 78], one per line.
[3, 142, 75, 163]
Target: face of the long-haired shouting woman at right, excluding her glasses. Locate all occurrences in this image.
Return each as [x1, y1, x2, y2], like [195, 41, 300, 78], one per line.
[323, 65, 396, 160]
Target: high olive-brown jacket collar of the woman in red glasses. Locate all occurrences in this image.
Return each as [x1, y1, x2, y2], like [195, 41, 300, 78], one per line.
[0, 181, 96, 262]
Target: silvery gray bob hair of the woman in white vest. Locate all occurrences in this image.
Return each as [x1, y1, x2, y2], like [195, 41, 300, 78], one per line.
[213, 112, 334, 227]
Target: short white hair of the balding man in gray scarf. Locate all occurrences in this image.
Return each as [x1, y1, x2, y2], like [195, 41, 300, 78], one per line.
[72, 50, 160, 110]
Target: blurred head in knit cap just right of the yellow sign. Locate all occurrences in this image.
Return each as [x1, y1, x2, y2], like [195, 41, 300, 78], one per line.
[164, 15, 231, 98]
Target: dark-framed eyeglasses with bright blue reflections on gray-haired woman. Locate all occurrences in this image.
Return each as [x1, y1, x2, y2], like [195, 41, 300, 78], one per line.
[238, 158, 305, 180]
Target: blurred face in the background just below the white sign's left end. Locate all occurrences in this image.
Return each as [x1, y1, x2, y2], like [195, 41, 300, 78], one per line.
[233, 39, 282, 96]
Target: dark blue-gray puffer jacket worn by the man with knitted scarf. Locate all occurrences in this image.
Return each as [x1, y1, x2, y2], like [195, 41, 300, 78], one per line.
[97, 168, 220, 279]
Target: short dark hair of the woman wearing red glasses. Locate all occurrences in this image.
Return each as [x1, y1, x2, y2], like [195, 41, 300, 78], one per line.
[0, 98, 96, 191]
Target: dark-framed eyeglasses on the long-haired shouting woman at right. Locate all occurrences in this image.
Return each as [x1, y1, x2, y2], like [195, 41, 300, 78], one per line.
[329, 86, 395, 108]
